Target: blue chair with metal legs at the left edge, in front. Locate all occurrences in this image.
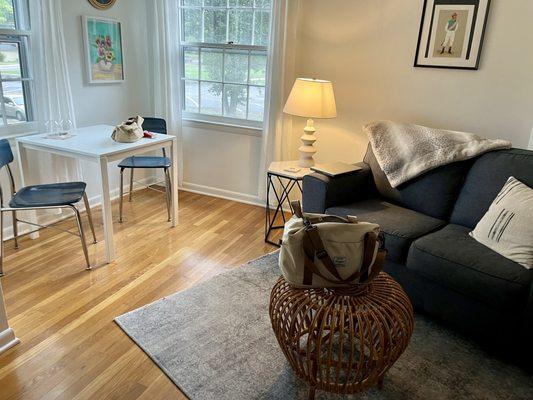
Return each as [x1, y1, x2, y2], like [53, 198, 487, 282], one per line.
[0, 139, 96, 276]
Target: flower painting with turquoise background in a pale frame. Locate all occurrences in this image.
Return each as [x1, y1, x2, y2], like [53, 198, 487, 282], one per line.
[82, 16, 126, 84]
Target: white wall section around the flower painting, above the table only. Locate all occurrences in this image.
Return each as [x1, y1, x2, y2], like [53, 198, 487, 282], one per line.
[62, 0, 151, 126]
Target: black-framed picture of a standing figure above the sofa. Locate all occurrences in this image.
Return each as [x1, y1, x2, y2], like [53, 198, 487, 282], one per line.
[415, 0, 490, 69]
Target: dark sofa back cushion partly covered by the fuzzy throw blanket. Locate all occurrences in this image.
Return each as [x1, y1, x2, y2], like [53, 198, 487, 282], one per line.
[364, 145, 473, 221]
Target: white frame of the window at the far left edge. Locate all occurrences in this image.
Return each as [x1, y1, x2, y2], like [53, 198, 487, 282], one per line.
[0, 0, 37, 137]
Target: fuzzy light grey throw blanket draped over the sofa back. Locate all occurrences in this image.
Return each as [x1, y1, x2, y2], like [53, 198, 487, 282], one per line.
[363, 121, 511, 187]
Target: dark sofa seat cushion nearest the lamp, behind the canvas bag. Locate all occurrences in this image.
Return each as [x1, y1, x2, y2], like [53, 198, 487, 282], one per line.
[326, 199, 445, 262]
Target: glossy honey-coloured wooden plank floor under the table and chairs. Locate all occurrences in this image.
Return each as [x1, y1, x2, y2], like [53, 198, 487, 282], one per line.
[0, 190, 274, 400]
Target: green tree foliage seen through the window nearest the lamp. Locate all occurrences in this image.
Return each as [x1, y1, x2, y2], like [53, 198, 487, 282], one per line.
[183, 0, 271, 116]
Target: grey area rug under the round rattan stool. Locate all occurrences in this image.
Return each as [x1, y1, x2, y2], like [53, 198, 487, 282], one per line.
[115, 253, 533, 400]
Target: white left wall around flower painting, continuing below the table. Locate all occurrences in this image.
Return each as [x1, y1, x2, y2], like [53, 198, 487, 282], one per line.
[2, 0, 152, 236]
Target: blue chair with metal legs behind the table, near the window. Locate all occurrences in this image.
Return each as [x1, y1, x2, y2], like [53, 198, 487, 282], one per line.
[118, 118, 171, 223]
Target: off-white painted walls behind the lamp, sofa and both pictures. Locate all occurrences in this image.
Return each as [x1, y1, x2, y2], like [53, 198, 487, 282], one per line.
[5, 0, 533, 228]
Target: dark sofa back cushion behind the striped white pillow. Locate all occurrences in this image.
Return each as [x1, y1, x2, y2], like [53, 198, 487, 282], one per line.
[450, 149, 533, 228]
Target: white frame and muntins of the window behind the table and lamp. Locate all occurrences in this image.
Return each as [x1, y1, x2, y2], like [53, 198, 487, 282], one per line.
[178, 0, 272, 130]
